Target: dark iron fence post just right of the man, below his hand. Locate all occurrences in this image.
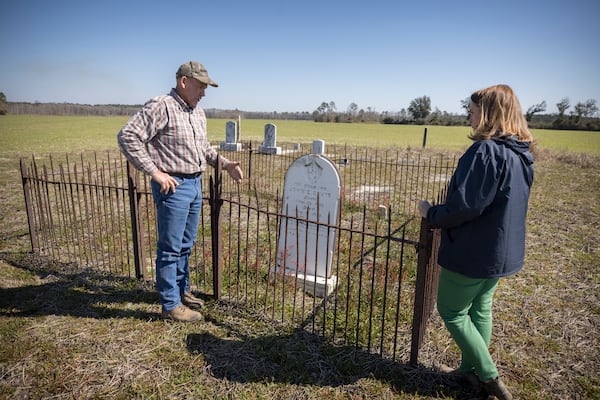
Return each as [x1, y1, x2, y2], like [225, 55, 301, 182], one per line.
[208, 156, 223, 300]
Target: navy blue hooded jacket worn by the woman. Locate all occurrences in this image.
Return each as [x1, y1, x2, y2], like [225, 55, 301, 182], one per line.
[427, 138, 533, 279]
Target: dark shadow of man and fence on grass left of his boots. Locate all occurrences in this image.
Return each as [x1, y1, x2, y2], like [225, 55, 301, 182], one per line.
[0, 252, 160, 321]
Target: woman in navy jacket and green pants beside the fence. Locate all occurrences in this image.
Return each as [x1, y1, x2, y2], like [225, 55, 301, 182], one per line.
[419, 85, 533, 399]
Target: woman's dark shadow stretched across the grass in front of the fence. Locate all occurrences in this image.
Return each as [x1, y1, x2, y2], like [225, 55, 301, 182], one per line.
[187, 329, 477, 399]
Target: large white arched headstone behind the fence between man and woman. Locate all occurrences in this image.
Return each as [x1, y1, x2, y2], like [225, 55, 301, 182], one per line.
[277, 154, 341, 296]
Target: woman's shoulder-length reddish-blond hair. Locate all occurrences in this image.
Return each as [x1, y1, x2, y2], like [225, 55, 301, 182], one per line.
[469, 85, 534, 142]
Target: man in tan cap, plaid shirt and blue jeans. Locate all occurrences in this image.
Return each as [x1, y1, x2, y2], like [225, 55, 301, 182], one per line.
[117, 61, 243, 321]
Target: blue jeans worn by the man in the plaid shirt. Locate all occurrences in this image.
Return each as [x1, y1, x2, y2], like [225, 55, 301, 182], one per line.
[151, 177, 202, 311]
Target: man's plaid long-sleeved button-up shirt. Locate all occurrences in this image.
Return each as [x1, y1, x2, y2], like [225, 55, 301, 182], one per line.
[117, 89, 229, 175]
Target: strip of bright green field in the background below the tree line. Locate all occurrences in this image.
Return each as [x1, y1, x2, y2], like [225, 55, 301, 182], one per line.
[0, 115, 600, 155]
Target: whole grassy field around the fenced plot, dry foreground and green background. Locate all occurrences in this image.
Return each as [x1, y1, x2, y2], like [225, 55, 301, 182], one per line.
[0, 116, 600, 400]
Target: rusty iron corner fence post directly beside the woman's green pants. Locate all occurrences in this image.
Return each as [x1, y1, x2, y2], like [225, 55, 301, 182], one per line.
[410, 218, 439, 366]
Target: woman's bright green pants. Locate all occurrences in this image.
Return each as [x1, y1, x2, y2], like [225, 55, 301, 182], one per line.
[437, 268, 498, 382]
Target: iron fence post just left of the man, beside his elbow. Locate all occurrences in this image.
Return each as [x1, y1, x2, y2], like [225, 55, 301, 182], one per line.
[127, 161, 146, 279]
